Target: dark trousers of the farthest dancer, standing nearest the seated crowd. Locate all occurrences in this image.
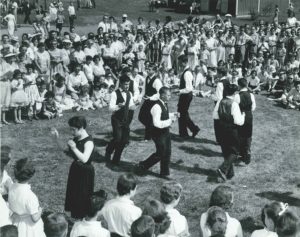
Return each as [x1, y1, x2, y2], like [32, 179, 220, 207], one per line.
[178, 93, 198, 137]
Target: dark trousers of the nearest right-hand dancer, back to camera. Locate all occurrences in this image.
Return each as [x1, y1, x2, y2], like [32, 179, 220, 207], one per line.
[220, 124, 239, 179]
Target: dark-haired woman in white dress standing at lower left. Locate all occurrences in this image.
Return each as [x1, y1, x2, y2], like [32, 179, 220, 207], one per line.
[8, 159, 46, 237]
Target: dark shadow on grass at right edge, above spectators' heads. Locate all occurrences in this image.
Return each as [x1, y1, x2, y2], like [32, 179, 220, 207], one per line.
[255, 191, 300, 207]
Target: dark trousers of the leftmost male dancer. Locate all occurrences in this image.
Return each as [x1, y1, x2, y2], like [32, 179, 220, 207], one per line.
[106, 117, 129, 164]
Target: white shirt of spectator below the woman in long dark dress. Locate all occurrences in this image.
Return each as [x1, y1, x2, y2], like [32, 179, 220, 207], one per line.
[70, 219, 110, 237]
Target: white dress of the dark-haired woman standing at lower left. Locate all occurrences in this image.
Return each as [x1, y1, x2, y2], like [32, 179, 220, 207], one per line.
[8, 183, 46, 237]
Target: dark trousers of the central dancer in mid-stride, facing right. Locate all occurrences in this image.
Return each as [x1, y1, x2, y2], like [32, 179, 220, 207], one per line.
[140, 131, 171, 175]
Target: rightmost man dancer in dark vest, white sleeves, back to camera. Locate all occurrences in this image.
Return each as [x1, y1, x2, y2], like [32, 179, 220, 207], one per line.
[235, 78, 256, 165]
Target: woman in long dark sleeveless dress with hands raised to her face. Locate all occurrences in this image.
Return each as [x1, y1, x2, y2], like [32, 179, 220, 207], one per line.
[65, 116, 95, 218]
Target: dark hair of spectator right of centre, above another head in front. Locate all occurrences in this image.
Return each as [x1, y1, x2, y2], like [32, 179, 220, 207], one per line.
[209, 185, 233, 210]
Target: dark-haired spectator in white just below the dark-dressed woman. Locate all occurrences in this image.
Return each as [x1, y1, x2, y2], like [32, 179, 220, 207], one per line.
[70, 190, 110, 237]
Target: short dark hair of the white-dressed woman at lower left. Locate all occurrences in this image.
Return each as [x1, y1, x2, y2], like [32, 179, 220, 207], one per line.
[14, 158, 35, 182]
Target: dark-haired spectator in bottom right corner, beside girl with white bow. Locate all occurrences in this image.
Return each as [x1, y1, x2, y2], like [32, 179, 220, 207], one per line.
[276, 210, 300, 237]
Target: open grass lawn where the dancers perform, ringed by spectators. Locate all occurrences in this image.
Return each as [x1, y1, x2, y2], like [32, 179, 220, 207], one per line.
[1, 91, 300, 237]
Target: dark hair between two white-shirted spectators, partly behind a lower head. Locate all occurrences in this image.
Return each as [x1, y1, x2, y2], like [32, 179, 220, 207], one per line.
[143, 198, 171, 235]
